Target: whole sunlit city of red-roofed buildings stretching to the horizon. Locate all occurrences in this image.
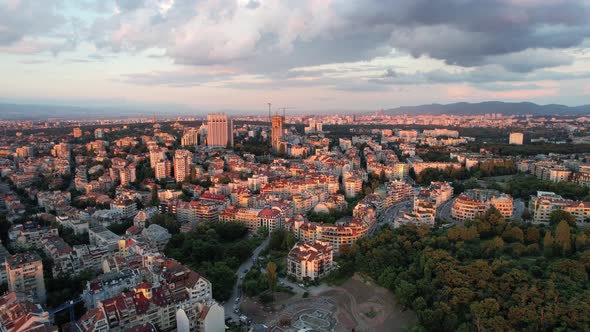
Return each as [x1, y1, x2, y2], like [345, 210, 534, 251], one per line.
[0, 110, 590, 332]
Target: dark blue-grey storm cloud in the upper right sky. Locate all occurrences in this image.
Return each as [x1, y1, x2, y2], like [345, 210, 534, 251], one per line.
[336, 0, 590, 71]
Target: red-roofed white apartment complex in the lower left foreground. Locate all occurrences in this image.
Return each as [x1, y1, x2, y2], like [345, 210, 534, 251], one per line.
[77, 260, 225, 332]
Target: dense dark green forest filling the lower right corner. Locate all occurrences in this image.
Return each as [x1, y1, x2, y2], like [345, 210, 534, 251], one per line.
[334, 209, 590, 331]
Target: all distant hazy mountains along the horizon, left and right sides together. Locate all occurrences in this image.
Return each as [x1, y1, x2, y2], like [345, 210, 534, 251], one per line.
[0, 101, 590, 120]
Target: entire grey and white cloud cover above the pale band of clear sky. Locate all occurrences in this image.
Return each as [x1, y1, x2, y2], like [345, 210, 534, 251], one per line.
[0, 0, 590, 101]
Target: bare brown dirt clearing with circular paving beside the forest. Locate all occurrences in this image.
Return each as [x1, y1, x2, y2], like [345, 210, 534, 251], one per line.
[242, 275, 416, 332]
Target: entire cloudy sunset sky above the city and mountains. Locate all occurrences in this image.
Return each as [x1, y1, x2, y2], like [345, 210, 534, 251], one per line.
[0, 0, 590, 112]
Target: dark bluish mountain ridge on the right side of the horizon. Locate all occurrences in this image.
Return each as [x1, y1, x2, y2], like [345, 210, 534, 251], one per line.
[384, 101, 590, 115]
